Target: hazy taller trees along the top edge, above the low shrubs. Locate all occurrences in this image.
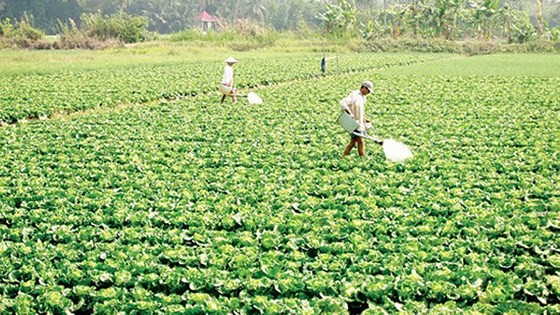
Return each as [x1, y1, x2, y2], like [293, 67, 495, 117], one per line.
[0, 0, 560, 41]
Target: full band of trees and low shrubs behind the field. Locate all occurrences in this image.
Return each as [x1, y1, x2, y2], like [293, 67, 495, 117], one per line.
[0, 0, 560, 53]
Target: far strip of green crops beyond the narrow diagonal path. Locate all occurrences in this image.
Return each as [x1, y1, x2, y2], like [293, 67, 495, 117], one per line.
[0, 54, 448, 123]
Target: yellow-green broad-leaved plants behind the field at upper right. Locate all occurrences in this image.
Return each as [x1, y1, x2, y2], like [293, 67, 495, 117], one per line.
[360, 0, 552, 43]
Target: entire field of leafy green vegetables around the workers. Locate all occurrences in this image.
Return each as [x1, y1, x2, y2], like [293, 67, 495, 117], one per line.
[0, 53, 560, 314]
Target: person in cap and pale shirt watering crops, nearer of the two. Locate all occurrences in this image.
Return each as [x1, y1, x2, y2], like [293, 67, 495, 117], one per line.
[340, 81, 373, 156]
